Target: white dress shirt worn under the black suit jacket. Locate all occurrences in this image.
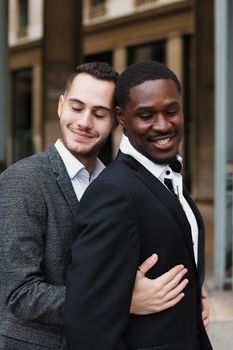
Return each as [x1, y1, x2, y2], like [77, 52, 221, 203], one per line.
[120, 134, 198, 264]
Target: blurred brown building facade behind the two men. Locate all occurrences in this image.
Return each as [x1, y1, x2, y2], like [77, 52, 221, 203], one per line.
[0, 0, 233, 288]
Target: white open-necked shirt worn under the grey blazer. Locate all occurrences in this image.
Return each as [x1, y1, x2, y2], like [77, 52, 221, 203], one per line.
[55, 139, 105, 201]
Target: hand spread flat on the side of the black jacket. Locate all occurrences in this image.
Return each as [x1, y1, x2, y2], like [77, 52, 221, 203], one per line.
[130, 254, 188, 320]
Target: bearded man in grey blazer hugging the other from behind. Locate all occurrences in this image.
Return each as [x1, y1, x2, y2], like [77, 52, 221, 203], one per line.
[0, 63, 204, 350]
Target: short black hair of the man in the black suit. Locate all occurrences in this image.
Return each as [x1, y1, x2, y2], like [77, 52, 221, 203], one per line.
[115, 61, 181, 107]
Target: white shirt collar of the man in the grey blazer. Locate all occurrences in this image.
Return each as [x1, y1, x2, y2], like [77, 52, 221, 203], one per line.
[55, 139, 105, 180]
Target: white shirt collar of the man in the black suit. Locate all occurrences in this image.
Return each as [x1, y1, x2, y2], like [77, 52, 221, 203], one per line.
[120, 134, 182, 178]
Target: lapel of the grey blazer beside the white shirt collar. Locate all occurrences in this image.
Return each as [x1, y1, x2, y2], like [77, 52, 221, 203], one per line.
[47, 145, 78, 215]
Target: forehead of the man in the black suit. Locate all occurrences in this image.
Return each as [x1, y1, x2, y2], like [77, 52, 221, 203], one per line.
[129, 79, 181, 104]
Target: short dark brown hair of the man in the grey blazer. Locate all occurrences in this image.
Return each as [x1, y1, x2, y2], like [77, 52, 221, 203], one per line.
[65, 62, 118, 91]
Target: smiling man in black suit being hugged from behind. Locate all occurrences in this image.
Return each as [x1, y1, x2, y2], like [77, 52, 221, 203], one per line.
[65, 61, 212, 350]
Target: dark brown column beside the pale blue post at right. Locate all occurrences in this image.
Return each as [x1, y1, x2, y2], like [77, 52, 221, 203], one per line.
[194, 0, 214, 202]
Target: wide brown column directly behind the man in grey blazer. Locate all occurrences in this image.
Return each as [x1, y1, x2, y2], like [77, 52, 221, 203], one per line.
[43, 0, 82, 148]
